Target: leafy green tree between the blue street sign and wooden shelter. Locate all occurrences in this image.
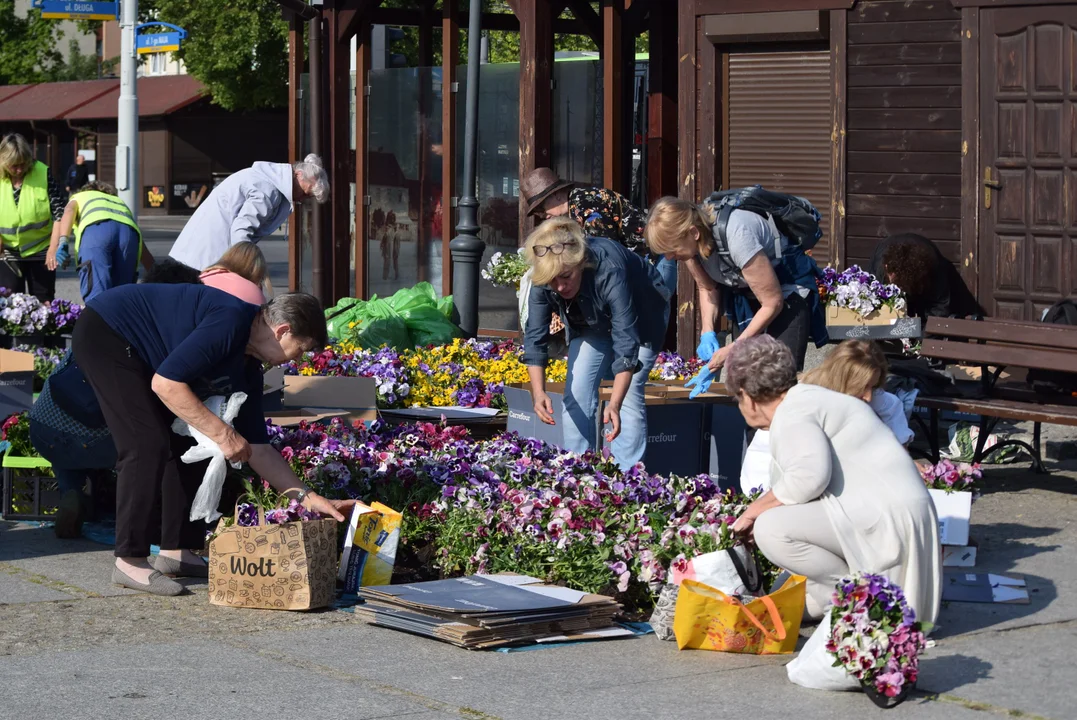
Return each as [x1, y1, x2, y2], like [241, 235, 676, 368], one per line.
[148, 0, 288, 110]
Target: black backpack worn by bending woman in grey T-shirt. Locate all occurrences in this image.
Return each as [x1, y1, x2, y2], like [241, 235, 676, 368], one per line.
[707, 185, 823, 287]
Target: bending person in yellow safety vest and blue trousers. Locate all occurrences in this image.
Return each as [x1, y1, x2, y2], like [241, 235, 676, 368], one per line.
[45, 182, 153, 301]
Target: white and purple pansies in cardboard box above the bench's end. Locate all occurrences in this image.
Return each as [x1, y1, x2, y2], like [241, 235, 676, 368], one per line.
[816, 265, 906, 326]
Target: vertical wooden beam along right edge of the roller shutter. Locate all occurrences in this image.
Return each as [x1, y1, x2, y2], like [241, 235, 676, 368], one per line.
[829, 10, 849, 268]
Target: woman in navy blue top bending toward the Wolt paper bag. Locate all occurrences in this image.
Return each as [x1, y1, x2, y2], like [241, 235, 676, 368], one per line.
[64, 284, 350, 595]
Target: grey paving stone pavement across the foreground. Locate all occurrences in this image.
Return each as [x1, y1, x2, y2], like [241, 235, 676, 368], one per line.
[0, 462, 1077, 720]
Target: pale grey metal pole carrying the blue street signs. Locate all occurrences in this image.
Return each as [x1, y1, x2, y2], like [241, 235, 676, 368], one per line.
[116, 0, 139, 220]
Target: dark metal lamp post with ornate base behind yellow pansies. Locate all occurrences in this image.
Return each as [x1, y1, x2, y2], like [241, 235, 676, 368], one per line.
[449, 0, 486, 338]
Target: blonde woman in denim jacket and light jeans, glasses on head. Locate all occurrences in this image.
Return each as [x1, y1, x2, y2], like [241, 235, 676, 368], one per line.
[523, 217, 670, 469]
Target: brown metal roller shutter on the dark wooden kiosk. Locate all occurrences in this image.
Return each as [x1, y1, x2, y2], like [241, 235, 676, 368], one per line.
[728, 51, 831, 266]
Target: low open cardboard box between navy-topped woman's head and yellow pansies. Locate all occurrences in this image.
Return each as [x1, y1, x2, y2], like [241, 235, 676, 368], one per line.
[263, 375, 378, 426]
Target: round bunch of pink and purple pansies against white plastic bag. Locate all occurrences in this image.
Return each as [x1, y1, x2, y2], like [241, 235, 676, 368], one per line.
[826, 573, 931, 708]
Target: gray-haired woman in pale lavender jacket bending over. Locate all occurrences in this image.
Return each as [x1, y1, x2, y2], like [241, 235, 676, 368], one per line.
[169, 154, 330, 270]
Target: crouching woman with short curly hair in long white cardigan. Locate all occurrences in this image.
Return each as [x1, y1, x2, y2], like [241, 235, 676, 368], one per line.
[726, 335, 942, 623]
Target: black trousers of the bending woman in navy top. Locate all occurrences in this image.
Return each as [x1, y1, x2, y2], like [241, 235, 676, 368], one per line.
[71, 308, 208, 557]
